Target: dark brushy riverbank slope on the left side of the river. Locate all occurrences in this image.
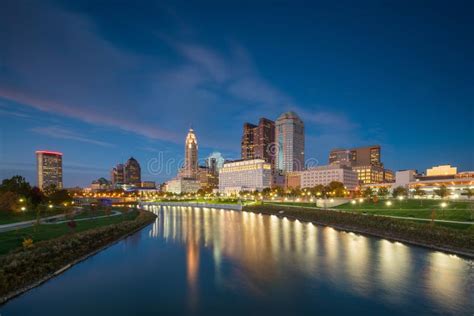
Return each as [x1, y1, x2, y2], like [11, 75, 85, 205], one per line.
[0, 210, 156, 304]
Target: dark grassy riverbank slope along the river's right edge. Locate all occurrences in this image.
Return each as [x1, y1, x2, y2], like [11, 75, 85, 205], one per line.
[242, 205, 474, 259]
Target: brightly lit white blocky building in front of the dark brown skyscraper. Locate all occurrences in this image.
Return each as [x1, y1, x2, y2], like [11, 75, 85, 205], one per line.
[219, 159, 272, 194]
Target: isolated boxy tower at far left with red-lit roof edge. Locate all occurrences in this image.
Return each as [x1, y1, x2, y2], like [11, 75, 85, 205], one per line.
[36, 150, 63, 190]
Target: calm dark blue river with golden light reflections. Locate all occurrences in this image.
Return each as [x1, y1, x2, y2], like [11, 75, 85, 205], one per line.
[0, 206, 474, 316]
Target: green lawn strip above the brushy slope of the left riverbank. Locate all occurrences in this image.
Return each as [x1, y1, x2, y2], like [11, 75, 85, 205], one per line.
[0, 211, 138, 255]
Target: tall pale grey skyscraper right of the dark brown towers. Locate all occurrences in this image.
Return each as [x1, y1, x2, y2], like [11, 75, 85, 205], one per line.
[275, 111, 304, 172]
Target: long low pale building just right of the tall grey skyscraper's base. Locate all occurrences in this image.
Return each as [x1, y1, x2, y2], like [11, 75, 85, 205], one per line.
[299, 164, 359, 190]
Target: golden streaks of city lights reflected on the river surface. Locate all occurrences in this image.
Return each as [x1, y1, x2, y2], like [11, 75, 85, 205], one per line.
[149, 206, 473, 312]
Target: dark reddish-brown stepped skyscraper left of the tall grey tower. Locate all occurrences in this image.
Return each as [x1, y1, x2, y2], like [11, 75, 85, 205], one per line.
[241, 117, 275, 163]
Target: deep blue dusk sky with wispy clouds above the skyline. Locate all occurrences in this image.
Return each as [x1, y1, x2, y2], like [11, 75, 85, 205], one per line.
[0, 0, 474, 186]
